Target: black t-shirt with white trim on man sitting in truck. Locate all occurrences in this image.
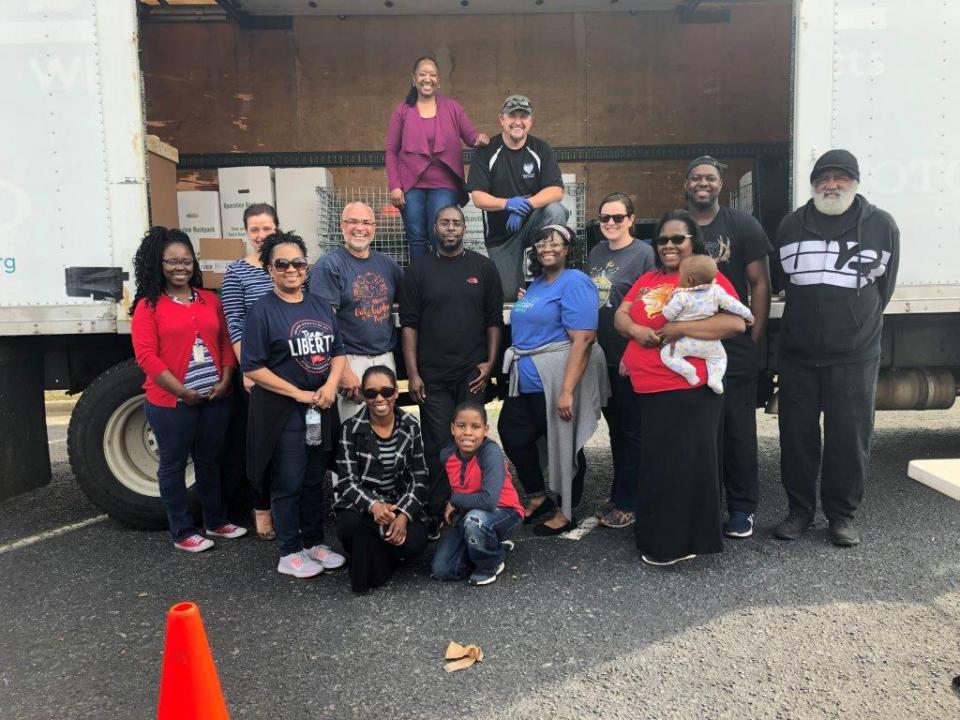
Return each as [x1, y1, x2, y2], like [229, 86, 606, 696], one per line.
[467, 135, 563, 246]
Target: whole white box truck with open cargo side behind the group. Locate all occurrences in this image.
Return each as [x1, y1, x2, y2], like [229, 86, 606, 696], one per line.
[0, 0, 960, 527]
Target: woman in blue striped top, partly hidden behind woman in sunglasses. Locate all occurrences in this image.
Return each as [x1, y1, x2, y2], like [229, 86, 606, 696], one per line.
[220, 203, 280, 540]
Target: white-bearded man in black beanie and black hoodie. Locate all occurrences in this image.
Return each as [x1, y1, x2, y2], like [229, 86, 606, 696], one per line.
[775, 150, 900, 547]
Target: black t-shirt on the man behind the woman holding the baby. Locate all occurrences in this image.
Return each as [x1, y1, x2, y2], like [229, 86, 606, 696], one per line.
[700, 202, 773, 375]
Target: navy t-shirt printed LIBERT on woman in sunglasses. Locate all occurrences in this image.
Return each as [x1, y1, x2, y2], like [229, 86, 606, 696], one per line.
[240, 292, 344, 390]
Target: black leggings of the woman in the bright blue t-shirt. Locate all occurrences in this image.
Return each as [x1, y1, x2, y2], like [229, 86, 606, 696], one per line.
[497, 393, 587, 507]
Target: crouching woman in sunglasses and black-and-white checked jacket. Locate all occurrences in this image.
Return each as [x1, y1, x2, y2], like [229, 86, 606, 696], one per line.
[333, 365, 429, 593]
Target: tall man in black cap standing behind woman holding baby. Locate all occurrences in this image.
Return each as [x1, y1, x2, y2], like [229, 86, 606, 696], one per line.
[684, 155, 772, 538]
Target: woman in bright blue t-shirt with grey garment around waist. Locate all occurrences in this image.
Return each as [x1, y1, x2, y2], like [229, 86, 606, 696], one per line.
[498, 225, 609, 535]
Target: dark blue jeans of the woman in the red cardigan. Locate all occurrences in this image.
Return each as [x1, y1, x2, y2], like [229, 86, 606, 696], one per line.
[144, 397, 233, 542]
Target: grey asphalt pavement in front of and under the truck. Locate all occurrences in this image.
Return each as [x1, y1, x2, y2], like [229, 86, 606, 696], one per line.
[0, 408, 960, 720]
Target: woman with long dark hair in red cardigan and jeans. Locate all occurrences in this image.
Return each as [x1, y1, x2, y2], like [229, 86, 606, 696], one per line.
[130, 226, 247, 552]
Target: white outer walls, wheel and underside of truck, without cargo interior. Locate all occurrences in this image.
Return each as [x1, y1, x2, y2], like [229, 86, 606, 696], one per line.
[0, 0, 960, 527]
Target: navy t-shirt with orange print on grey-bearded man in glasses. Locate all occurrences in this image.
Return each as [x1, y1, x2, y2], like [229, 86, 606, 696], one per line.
[309, 247, 403, 355]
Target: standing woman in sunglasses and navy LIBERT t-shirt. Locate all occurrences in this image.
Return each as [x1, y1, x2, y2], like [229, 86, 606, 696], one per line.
[240, 232, 345, 578]
